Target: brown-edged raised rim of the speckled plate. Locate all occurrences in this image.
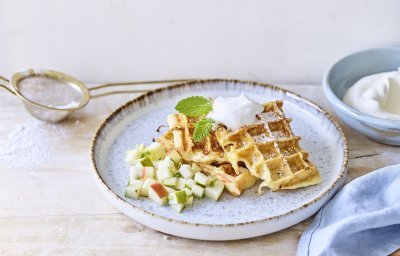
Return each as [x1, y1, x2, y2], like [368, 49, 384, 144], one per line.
[90, 78, 349, 228]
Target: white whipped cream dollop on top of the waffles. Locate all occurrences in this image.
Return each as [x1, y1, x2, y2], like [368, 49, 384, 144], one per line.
[208, 94, 264, 130]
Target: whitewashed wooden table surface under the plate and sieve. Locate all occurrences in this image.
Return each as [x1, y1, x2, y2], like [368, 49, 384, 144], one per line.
[0, 85, 400, 256]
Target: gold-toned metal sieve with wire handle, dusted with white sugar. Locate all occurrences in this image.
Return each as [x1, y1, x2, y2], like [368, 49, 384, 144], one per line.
[0, 69, 194, 122]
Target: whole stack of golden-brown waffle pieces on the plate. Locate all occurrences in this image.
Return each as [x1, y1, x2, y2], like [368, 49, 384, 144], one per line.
[156, 101, 321, 196]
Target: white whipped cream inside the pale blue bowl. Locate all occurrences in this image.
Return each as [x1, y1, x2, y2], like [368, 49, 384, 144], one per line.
[343, 68, 400, 120]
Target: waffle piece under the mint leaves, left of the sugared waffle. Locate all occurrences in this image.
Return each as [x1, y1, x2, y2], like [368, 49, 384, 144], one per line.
[168, 114, 227, 163]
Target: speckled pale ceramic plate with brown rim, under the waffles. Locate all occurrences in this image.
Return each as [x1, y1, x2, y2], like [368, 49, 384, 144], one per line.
[91, 80, 348, 240]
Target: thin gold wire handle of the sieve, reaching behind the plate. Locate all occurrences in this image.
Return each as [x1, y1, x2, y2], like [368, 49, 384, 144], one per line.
[88, 79, 198, 98]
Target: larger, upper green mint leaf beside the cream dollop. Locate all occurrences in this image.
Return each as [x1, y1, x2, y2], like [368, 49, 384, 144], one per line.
[175, 96, 212, 117]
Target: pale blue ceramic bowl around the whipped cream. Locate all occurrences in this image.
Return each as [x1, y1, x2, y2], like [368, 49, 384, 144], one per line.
[322, 48, 400, 146]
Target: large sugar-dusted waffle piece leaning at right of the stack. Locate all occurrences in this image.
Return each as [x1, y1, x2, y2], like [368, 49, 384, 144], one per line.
[215, 101, 321, 191]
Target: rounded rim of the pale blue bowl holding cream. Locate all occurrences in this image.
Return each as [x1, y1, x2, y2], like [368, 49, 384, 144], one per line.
[322, 47, 400, 129]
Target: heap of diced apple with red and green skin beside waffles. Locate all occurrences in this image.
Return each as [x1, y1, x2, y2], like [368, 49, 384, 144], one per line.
[125, 142, 224, 213]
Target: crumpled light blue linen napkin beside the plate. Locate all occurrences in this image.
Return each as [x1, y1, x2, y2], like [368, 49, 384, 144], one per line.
[297, 165, 400, 256]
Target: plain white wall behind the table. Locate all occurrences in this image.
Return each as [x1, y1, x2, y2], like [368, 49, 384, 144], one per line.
[0, 0, 400, 83]
